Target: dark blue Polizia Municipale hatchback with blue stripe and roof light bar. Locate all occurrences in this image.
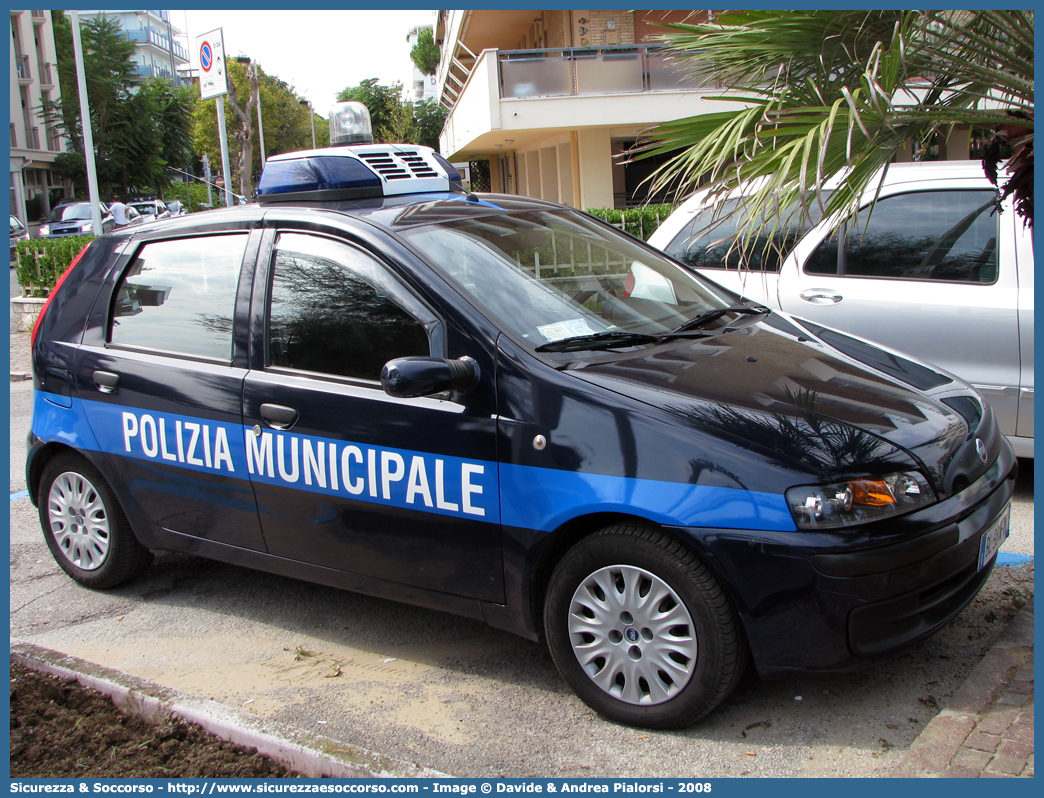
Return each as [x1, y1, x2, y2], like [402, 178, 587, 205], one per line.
[27, 104, 1016, 728]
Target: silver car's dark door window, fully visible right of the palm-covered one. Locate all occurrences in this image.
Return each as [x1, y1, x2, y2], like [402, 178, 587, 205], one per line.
[805, 190, 997, 283]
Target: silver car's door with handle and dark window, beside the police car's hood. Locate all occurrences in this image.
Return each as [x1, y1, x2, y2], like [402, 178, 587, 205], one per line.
[778, 181, 1020, 436]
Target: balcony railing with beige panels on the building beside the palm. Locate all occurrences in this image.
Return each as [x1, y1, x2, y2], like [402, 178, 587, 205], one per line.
[498, 45, 720, 99]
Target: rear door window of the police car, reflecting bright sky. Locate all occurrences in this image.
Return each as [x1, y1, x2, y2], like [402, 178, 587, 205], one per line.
[109, 235, 247, 360]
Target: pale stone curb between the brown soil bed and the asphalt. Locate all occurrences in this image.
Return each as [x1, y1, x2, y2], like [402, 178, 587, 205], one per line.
[10, 638, 453, 778]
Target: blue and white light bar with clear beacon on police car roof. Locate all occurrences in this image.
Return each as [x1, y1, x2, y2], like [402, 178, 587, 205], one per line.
[258, 102, 462, 205]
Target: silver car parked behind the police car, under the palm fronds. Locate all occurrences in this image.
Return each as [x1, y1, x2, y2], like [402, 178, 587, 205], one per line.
[649, 161, 1034, 457]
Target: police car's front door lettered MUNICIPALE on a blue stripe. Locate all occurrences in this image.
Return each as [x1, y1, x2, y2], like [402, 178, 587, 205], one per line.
[243, 229, 503, 602]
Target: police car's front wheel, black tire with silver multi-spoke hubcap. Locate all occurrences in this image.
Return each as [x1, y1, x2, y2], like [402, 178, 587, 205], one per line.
[544, 526, 750, 729]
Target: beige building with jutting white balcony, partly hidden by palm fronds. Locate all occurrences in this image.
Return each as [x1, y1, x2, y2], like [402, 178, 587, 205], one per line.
[435, 9, 747, 208]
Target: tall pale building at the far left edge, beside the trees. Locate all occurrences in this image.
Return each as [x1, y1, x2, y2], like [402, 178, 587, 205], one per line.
[10, 10, 68, 226]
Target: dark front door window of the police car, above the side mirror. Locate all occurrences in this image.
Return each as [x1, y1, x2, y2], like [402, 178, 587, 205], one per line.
[268, 233, 434, 380]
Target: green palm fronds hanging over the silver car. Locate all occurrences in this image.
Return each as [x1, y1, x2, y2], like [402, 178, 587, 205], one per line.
[637, 10, 1034, 249]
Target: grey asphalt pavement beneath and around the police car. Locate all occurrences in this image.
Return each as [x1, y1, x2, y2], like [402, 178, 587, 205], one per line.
[10, 382, 1034, 777]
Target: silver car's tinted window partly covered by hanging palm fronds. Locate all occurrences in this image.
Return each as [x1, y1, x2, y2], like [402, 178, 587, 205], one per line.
[664, 197, 830, 272]
